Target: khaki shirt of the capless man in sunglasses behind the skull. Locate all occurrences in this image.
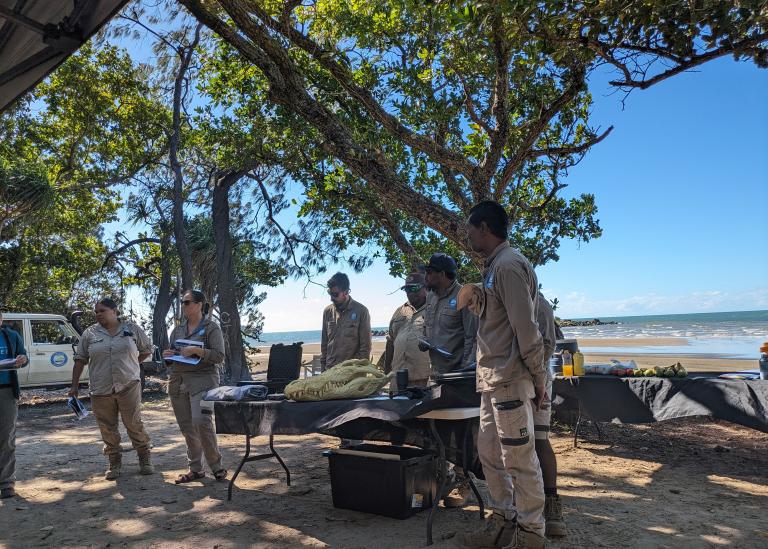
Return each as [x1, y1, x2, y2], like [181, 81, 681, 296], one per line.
[320, 297, 371, 371]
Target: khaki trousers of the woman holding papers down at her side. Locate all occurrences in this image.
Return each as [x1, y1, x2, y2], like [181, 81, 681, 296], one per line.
[91, 381, 149, 456]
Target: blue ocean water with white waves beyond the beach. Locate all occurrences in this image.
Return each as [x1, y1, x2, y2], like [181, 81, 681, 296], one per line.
[254, 311, 768, 359]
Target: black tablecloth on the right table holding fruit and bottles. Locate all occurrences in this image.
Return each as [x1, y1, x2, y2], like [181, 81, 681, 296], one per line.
[553, 376, 768, 432]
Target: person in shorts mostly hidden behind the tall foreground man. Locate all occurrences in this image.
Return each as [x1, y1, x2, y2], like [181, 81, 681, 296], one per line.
[533, 292, 566, 537]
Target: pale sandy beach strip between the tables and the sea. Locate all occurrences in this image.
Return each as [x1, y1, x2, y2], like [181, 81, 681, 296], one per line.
[249, 337, 757, 372]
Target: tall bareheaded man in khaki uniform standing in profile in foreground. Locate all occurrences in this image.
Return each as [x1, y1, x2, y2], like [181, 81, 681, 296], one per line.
[457, 201, 547, 549]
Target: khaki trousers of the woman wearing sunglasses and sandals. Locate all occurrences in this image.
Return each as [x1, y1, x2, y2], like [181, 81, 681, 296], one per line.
[170, 383, 222, 473]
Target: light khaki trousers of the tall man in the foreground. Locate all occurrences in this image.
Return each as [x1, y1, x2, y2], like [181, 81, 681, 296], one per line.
[477, 384, 544, 536]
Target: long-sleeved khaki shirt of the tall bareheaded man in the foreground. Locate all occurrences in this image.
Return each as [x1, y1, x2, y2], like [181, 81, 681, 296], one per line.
[477, 242, 547, 392]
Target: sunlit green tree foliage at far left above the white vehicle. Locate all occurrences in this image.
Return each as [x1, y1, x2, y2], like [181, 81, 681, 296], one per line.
[0, 45, 164, 312]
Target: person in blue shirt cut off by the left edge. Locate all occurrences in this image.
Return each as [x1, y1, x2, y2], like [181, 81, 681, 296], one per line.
[0, 311, 28, 499]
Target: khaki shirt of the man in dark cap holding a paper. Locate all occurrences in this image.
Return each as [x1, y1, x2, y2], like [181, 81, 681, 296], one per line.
[424, 281, 477, 374]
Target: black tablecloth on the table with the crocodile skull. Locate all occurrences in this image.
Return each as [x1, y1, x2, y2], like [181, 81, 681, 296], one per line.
[214, 380, 482, 478]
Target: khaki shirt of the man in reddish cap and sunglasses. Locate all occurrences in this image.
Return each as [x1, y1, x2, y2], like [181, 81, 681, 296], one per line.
[384, 303, 430, 385]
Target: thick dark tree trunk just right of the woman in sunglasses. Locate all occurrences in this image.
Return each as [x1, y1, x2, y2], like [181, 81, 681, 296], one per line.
[212, 176, 251, 381]
